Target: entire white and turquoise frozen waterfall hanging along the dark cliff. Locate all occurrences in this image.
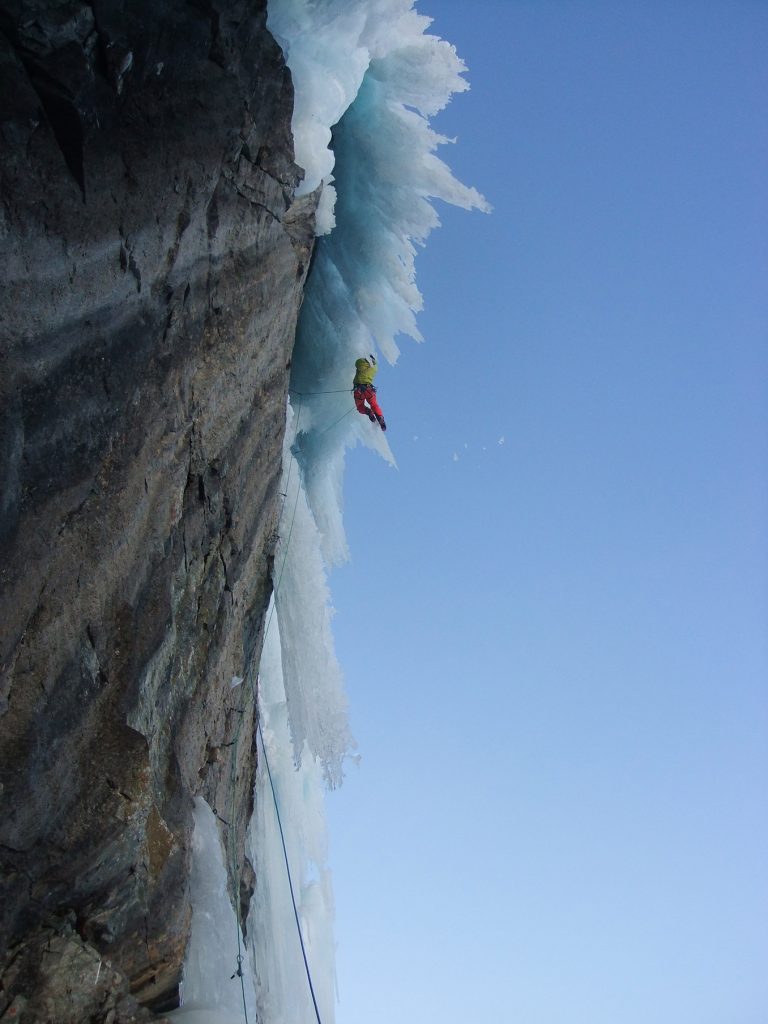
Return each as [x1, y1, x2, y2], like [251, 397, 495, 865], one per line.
[184, 0, 487, 1024]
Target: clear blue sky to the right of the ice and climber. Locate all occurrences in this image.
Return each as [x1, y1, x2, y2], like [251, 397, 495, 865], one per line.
[329, 0, 768, 1024]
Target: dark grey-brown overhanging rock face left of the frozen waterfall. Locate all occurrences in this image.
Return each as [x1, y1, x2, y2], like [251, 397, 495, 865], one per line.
[0, 0, 314, 1024]
